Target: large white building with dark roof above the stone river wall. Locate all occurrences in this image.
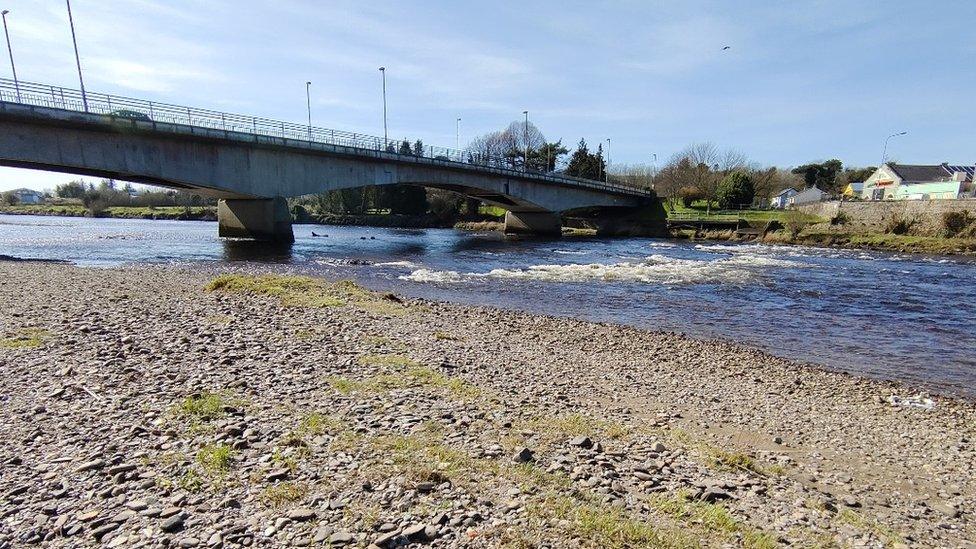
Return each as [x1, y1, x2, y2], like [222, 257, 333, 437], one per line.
[861, 162, 976, 200]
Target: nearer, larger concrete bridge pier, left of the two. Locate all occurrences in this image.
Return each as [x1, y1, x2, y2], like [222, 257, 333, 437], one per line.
[217, 196, 295, 242]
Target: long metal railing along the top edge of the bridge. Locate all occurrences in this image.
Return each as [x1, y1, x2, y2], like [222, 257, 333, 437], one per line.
[0, 78, 652, 196]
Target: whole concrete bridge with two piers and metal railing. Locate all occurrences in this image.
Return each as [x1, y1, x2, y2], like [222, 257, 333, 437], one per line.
[0, 79, 652, 241]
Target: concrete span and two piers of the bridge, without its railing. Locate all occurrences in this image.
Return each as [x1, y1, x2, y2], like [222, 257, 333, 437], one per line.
[0, 103, 656, 240]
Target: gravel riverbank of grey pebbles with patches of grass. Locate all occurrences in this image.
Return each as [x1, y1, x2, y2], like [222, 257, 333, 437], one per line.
[0, 262, 976, 548]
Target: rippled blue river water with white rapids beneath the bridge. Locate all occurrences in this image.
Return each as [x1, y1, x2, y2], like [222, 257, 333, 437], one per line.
[0, 215, 976, 396]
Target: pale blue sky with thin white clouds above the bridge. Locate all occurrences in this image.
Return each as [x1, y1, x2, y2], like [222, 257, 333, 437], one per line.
[0, 0, 976, 189]
